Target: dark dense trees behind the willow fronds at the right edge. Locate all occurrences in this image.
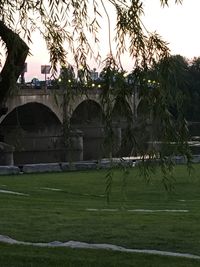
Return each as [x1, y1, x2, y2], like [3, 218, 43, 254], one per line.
[153, 55, 200, 122]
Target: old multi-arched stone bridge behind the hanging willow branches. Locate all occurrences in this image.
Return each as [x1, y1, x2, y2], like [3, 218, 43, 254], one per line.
[0, 88, 138, 165]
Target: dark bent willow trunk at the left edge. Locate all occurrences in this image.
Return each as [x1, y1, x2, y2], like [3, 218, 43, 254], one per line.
[0, 21, 29, 116]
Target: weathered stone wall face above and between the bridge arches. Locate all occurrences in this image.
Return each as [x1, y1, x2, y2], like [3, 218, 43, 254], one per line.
[0, 87, 139, 123]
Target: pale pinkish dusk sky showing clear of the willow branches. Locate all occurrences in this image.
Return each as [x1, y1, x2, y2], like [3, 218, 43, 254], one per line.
[25, 0, 200, 81]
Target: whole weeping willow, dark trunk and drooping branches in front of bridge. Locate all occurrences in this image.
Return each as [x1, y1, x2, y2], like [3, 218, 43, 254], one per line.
[0, 0, 192, 183]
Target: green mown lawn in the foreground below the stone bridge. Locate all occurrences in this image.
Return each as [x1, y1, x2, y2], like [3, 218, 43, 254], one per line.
[0, 165, 200, 267]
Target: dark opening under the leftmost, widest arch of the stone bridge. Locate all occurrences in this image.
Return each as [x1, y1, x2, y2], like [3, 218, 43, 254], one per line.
[0, 102, 62, 164]
